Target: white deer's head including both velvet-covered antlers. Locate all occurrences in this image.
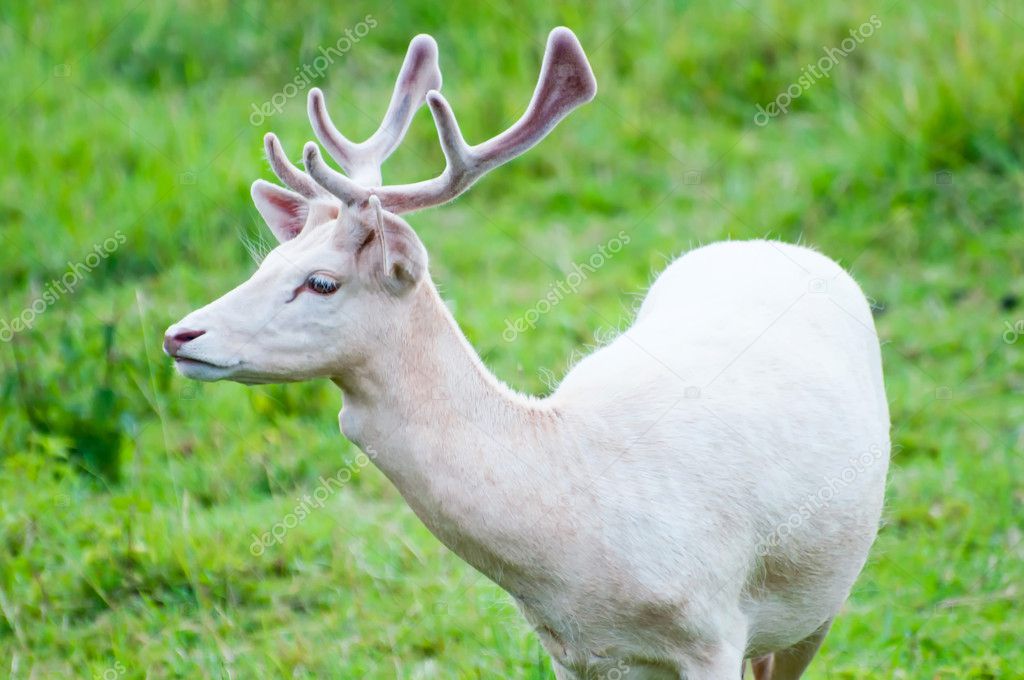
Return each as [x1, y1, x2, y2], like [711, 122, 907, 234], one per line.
[164, 28, 597, 383]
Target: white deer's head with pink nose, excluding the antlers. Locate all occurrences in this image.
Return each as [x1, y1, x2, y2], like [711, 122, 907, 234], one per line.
[164, 199, 427, 384]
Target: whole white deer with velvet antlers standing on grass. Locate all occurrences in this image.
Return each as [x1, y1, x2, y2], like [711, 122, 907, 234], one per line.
[164, 28, 889, 680]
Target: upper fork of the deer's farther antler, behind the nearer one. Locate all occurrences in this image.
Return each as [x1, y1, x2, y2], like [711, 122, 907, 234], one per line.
[308, 35, 441, 186]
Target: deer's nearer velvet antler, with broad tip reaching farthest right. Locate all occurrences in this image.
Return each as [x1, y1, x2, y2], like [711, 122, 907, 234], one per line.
[299, 28, 597, 213]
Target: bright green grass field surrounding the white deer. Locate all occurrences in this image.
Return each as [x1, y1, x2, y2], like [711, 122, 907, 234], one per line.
[0, 0, 1024, 680]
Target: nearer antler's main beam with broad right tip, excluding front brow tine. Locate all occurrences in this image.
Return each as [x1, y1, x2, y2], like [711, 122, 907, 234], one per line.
[374, 27, 597, 213]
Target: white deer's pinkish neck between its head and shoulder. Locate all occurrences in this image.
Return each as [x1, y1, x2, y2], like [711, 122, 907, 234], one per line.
[335, 281, 572, 593]
